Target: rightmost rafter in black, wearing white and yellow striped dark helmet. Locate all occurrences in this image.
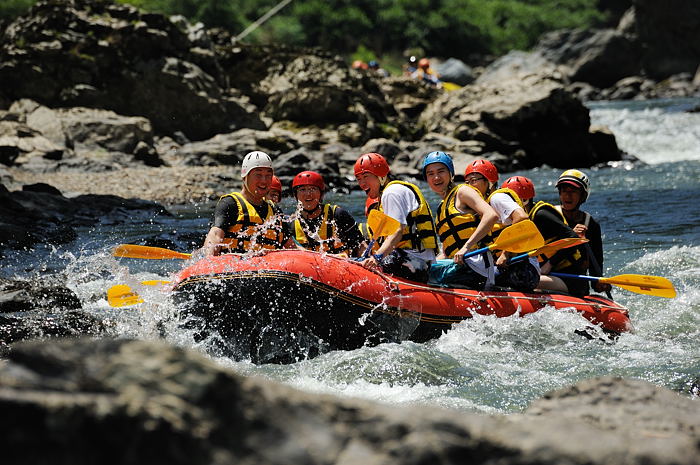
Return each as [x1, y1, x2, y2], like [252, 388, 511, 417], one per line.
[555, 170, 612, 292]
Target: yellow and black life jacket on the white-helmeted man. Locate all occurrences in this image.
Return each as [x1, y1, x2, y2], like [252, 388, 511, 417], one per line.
[221, 192, 284, 253]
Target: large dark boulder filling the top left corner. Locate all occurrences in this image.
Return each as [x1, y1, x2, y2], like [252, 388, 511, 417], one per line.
[0, 0, 264, 139]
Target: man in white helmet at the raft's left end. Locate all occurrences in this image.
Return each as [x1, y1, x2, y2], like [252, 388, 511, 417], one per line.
[203, 151, 288, 255]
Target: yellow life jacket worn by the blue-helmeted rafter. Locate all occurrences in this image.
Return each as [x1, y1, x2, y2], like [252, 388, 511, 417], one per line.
[436, 184, 482, 258]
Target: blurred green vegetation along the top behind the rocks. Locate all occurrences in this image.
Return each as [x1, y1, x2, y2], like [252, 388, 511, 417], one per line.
[0, 0, 632, 67]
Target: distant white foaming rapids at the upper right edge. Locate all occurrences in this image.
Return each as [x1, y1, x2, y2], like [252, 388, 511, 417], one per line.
[590, 108, 700, 164]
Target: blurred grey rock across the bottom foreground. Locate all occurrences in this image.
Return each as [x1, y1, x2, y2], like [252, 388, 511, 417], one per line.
[0, 339, 700, 465]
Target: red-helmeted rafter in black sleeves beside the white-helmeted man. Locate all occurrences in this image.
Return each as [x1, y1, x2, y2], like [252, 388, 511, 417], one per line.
[291, 171, 365, 256]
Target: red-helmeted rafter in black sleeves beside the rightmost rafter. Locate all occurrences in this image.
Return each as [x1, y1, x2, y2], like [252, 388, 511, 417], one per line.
[502, 176, 588, 296]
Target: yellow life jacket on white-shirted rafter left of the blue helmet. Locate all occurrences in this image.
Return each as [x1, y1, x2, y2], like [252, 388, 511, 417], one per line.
[379, 181, 437, 251]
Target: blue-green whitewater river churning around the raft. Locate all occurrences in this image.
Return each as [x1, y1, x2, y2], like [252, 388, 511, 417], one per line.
[2, 99, 700, 413]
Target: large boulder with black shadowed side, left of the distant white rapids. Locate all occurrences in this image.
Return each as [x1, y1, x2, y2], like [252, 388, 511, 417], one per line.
[421, 73, 620, 168]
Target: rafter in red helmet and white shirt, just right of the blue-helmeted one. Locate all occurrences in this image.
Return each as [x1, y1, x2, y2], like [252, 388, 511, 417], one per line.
[464, 159, 540, 292]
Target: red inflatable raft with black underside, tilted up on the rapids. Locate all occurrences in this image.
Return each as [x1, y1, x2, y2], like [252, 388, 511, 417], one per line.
[173, 250, 632, 363]
